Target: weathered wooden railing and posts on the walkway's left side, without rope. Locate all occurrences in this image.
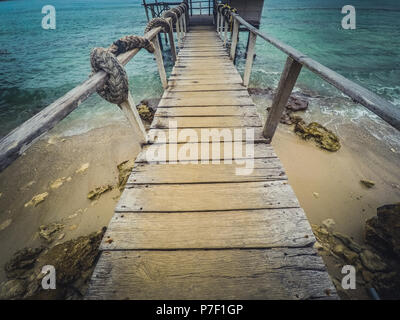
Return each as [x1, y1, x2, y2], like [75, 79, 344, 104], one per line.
[0, 9, 187, 172]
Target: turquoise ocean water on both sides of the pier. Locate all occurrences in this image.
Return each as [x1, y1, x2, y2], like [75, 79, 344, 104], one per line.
[0, 0, 400, 139]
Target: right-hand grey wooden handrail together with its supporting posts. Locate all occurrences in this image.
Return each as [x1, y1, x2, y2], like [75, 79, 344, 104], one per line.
[217, 12, 400, 140]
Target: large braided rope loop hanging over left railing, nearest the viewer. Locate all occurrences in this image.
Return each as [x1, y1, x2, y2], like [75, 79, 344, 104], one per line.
[90, 48, 129, 104]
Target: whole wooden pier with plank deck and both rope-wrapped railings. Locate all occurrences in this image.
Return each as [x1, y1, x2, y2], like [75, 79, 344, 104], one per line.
[0, 1, 400, 299]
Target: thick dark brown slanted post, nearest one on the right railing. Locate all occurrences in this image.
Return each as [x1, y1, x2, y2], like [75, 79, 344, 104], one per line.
[263, 57, 302, 143]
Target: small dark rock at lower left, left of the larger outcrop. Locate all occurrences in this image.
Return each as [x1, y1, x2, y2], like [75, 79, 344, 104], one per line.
[4, 247, 44, 278]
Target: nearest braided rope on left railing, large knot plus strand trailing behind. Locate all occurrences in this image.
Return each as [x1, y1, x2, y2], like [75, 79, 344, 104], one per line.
[90, 36, 154, 105]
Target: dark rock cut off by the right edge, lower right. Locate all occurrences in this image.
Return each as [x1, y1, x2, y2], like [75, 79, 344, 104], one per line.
[365, 203, 400, 258]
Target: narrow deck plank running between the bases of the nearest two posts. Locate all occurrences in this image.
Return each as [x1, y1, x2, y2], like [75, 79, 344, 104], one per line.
[148, 127, 266, 143]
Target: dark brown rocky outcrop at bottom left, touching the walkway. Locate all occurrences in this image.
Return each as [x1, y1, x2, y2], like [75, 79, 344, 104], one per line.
[0, 228, 105, 299]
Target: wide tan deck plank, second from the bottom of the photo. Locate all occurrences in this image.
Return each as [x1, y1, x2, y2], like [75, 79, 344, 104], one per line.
[100, 208, 315, 250]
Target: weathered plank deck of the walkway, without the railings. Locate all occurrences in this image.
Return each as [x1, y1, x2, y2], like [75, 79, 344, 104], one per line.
[86, 26, 337, 299]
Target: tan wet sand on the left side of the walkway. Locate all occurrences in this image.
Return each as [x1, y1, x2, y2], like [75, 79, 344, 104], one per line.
[0, 122, 140, 282]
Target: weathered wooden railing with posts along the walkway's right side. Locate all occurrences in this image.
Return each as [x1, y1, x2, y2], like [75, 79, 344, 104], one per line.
[217, 10, 400, 142]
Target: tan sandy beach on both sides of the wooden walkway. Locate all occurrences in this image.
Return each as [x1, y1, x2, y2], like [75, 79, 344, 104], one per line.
[0, 90, 400, 297]
